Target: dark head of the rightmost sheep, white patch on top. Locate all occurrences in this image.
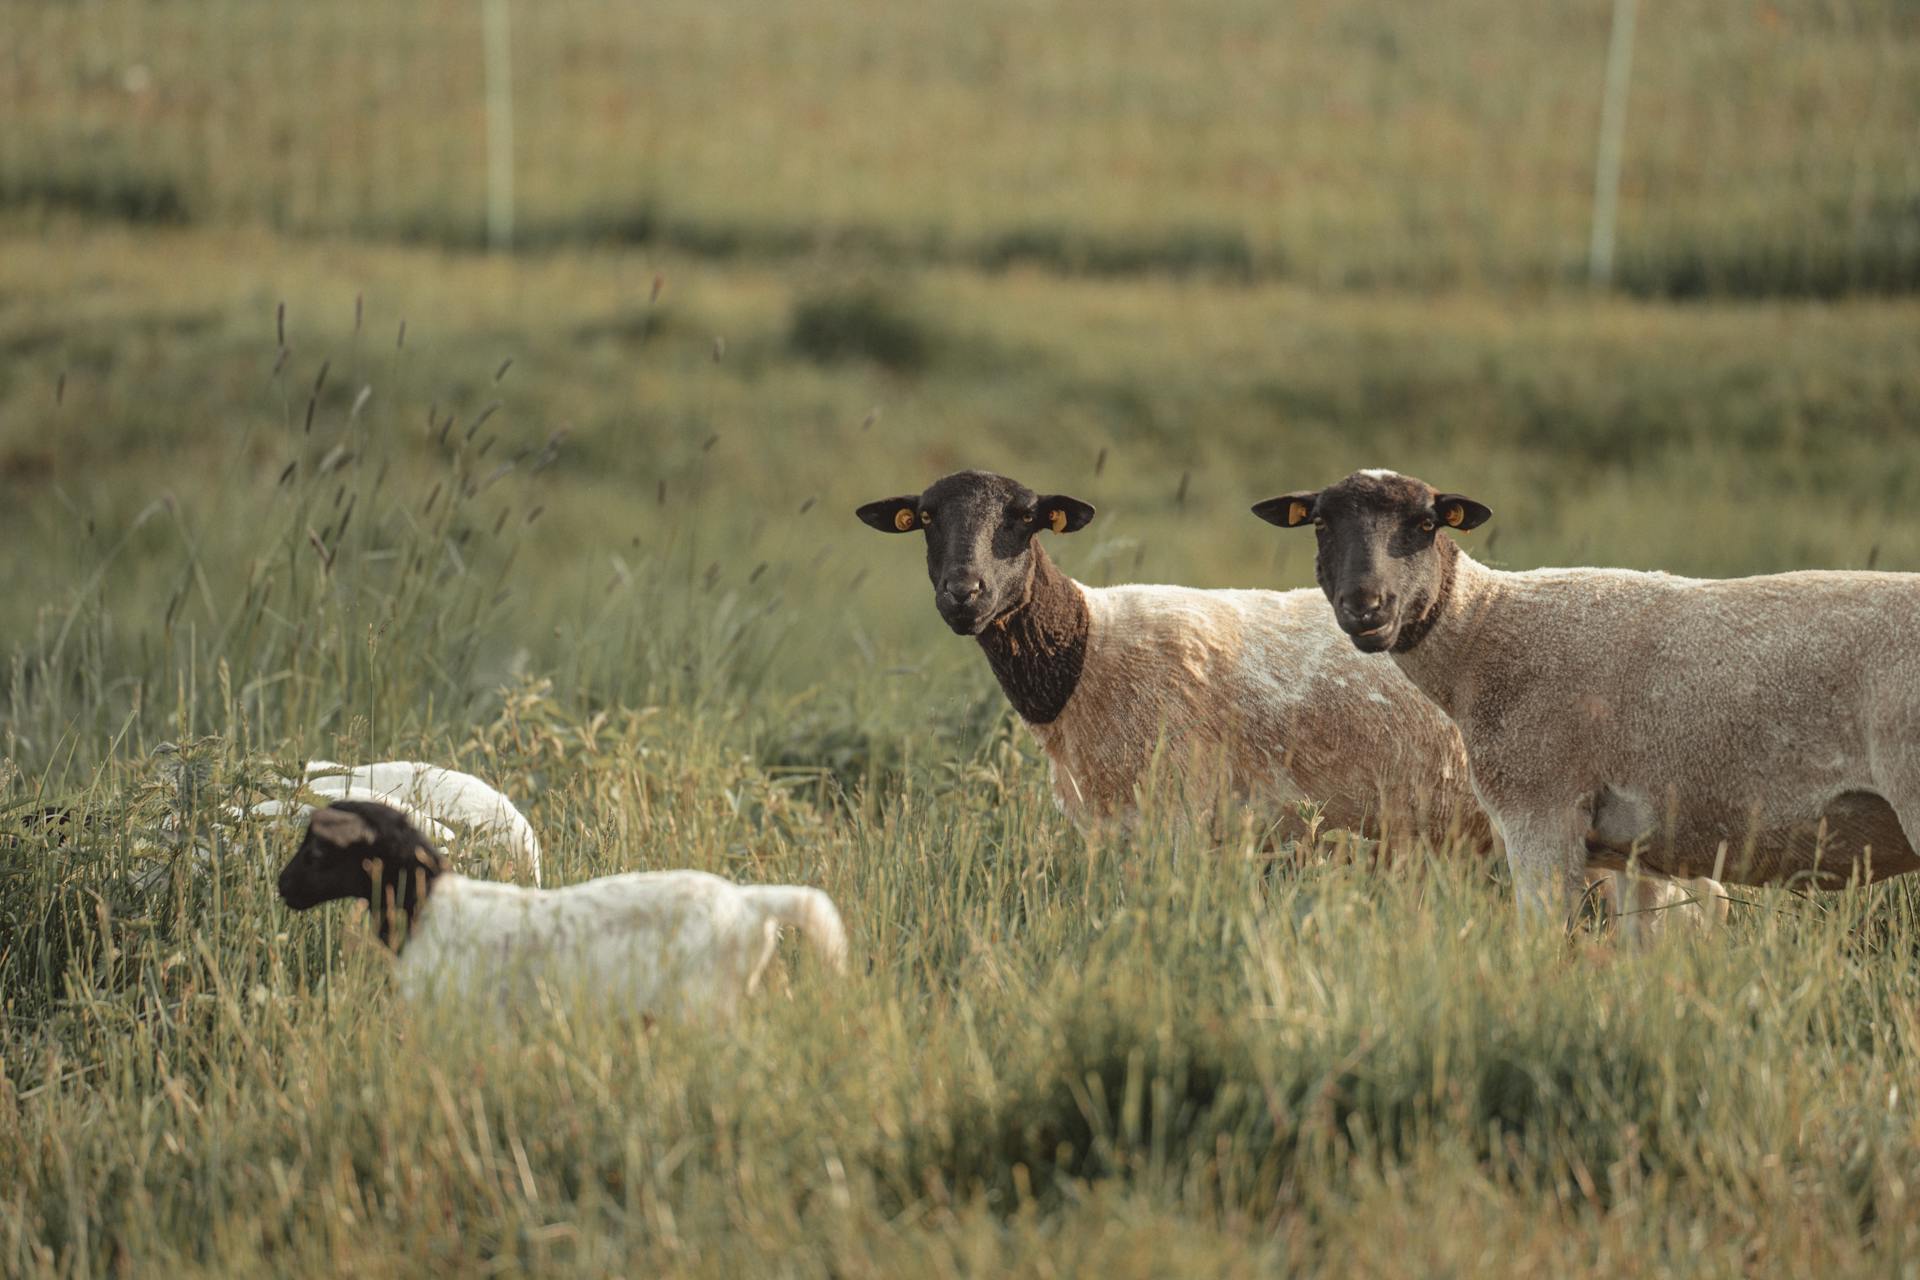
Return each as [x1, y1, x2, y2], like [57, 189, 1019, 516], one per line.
[1254, 470, 1494, 652]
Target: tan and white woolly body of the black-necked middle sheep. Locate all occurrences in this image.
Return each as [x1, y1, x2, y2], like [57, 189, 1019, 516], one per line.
[1031, 580, 1486, 839]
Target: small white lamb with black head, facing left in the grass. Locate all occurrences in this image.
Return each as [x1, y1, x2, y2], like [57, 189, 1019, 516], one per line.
[278, 800, 847, 1019]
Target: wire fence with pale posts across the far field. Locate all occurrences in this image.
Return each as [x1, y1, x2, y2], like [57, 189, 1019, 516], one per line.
[0, 0, 1920, 294]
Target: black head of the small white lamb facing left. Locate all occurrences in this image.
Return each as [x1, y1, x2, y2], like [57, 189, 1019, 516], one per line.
[280, 800, 447, 946]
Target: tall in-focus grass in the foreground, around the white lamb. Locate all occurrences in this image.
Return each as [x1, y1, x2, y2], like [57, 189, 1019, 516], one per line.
[11, 729, 1920, 1274]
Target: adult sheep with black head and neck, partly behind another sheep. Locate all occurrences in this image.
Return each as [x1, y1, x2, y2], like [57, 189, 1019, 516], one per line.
[854, 470, 1490, 844]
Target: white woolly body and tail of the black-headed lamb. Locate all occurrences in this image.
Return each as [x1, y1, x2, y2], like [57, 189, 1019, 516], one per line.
[396, 871, 847, 1019]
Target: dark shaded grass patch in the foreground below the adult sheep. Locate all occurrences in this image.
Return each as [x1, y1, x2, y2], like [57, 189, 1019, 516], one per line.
[900, 1002, 1684, 1213]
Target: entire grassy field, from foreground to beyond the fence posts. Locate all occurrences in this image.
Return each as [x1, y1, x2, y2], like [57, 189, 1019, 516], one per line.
[0, 0, 1920, 1274]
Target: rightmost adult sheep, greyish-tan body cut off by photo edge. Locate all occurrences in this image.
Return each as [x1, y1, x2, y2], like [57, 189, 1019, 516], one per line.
[1254, 470, 1920, 915]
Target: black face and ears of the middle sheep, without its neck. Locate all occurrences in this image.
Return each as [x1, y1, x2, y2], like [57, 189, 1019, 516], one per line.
[854, 470, 1092, 635]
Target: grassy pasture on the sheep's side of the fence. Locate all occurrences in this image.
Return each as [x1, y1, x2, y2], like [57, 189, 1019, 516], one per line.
[0, 219, 1920, 1274]
